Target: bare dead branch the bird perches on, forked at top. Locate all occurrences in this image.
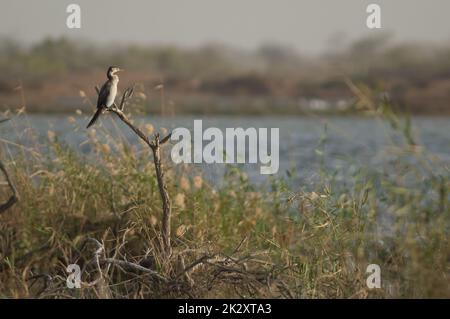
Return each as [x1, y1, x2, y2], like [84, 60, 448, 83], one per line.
[95, 87, 172, 257]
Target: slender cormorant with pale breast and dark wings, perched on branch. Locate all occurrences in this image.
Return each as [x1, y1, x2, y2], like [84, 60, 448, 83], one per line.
[86, 66, 123, 128]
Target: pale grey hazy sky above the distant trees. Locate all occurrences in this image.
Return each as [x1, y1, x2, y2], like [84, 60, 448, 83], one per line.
[0, 0, 450, 52]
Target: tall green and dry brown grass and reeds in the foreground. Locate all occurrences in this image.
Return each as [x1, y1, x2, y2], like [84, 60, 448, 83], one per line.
[0, 84, 450, 298]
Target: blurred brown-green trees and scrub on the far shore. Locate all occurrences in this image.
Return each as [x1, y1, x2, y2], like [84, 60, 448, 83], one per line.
[0, 34, 450, 114]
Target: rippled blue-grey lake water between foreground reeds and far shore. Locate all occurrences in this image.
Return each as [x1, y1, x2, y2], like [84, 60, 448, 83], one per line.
[0, 115, 450, 189]
